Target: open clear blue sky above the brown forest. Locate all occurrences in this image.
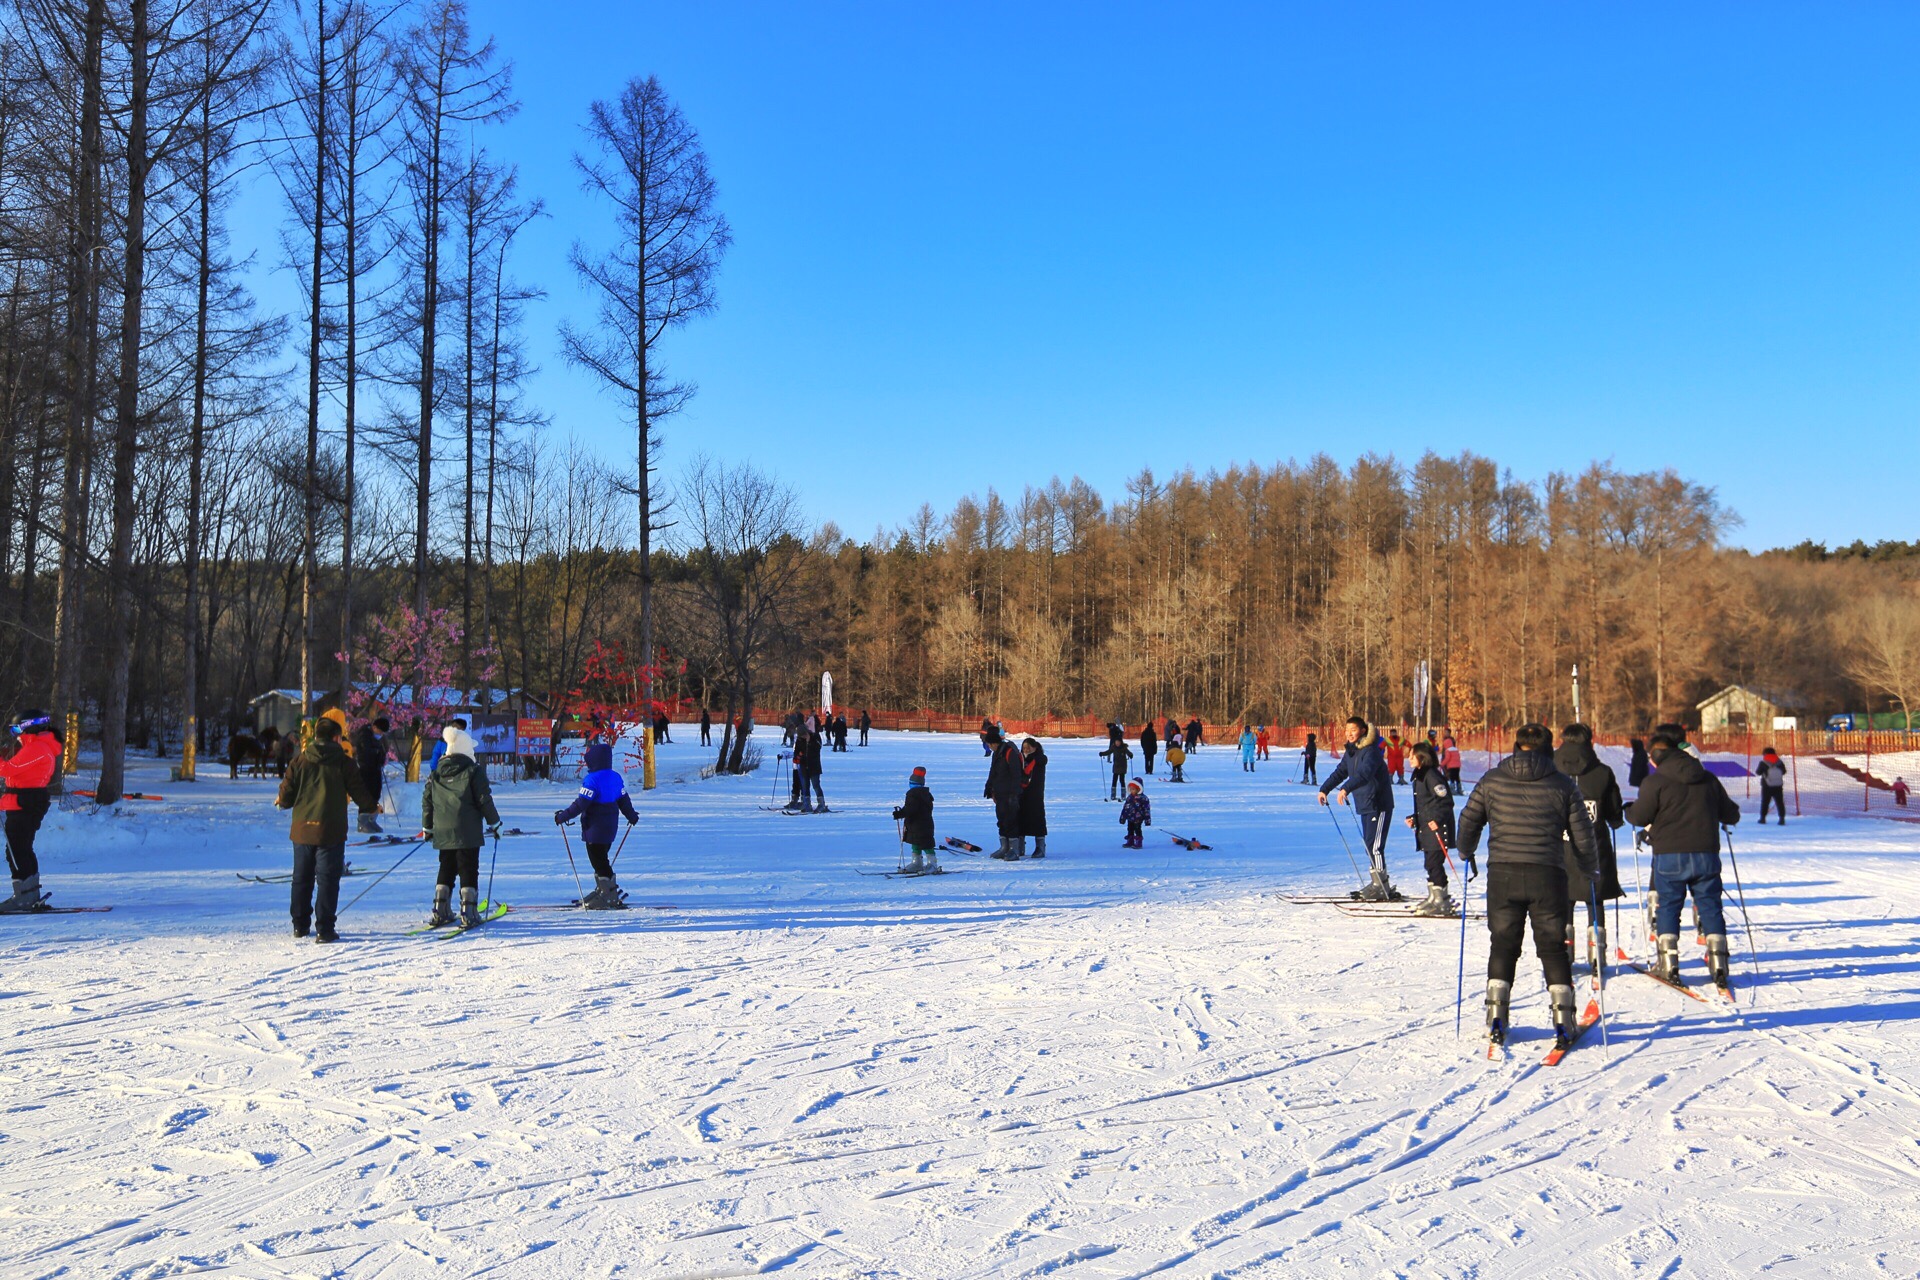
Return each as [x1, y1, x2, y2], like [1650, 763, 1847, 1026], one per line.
[243, 0, 1920, 547]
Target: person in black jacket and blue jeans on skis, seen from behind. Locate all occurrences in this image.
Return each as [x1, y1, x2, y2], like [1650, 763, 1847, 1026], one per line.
[1626, 733, 1740, 990]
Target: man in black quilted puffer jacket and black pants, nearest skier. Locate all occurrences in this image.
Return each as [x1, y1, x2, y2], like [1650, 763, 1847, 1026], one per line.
[1459, 723, 1599, 1044]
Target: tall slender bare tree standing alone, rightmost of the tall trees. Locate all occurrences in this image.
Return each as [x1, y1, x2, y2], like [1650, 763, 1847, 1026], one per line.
[561, 77, 732, 787]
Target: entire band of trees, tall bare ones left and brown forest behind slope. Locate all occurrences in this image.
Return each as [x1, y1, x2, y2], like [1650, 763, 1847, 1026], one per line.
[0, 0, 1920, 798]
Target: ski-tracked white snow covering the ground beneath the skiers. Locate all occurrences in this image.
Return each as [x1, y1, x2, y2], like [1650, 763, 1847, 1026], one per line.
[0, 731, 1920, 1280]
